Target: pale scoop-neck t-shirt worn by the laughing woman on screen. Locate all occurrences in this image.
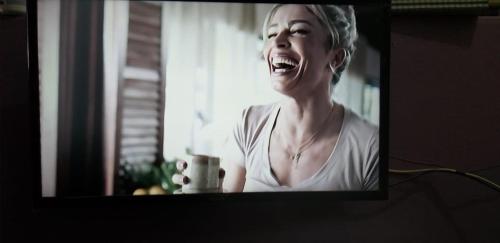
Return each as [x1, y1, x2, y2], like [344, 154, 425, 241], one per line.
[222, 103, 379, 192]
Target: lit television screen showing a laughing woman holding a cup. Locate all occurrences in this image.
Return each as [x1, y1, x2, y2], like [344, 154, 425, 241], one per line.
[33, 0, 389, 200]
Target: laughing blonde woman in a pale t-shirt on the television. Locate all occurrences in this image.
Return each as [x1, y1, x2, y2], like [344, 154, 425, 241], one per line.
[174, 5, 379, 192]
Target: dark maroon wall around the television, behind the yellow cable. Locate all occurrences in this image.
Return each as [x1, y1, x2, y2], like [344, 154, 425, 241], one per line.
[0, 16, 500, 242]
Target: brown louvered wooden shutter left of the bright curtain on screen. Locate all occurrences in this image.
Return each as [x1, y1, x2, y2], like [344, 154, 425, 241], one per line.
[117, 2, 164, 167]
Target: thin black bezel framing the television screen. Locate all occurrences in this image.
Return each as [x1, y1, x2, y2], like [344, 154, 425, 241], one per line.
[27, 0, 390, 210]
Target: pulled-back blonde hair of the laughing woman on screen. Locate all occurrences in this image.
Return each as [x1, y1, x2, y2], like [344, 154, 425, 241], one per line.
[262, 4, 358, 85]
